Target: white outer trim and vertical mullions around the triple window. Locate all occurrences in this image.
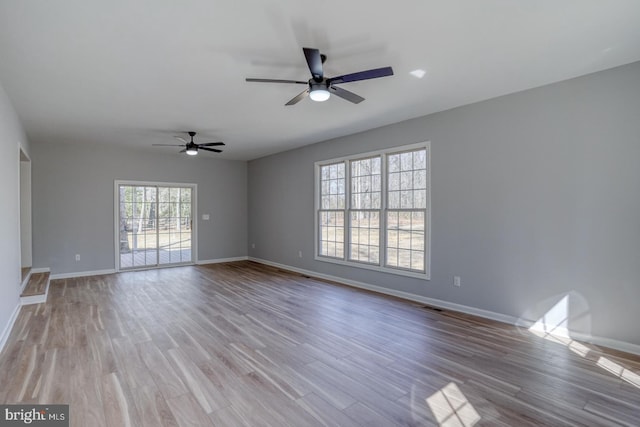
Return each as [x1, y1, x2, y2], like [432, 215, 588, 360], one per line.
[313, 141, 432, 280]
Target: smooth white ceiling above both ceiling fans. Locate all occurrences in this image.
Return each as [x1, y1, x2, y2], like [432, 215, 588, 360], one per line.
[0, 0, 640, 160]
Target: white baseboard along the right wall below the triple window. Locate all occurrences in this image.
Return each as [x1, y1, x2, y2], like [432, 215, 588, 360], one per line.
[249, 257, 640, 355]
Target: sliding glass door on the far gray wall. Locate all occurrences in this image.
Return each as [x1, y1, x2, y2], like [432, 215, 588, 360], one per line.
[116, 182, 195, 270]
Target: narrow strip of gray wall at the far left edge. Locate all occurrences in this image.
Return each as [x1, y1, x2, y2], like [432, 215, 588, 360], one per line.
[0, 79, 29, 338]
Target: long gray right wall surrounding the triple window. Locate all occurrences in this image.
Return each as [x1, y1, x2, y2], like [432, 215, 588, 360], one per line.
[248, 63, 640, 345]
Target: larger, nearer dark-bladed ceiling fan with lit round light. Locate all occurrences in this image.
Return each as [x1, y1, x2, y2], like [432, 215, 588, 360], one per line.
[245, 47, 393, 105]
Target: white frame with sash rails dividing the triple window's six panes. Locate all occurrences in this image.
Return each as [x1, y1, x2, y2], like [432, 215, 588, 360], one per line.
[314, 141, 431, 280]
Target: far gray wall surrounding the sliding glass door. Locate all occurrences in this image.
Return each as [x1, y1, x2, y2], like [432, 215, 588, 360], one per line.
[32, 142, 247, 274]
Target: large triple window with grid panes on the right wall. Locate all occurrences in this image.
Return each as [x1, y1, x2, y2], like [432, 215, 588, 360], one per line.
[316, 143, 430, 278]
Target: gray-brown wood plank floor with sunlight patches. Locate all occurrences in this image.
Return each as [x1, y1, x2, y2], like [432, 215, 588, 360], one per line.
[0, 262, 640, 427]
